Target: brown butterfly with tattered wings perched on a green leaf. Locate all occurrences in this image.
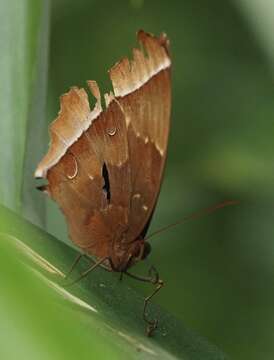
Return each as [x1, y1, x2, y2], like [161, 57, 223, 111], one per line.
[35, 31, 171, 335]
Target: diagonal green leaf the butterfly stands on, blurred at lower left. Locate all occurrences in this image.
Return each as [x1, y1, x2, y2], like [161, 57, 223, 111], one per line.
[0, 202, 229, 360]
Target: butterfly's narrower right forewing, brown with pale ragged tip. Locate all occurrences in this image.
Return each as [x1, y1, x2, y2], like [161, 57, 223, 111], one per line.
[110, 31, 171, 240]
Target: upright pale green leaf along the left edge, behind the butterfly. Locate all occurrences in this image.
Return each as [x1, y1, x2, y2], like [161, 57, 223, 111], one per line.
[0, 0, 49, 222]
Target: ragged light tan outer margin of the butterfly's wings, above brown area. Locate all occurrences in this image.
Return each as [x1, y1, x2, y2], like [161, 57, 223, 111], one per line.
[34, 30, 171, 178]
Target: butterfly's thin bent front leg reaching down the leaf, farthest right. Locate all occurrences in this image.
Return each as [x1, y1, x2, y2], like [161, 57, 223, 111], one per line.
[125, 266, 164, 336]
